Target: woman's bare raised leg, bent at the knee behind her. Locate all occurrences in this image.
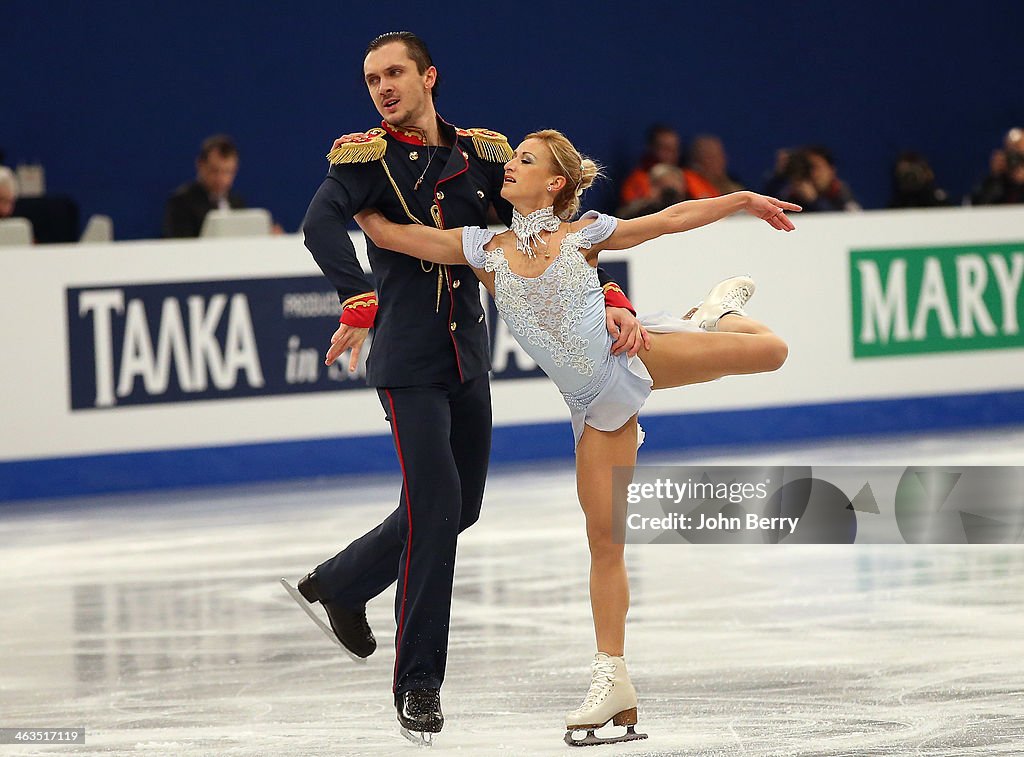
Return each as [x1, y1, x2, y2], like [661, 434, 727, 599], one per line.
[639, 313, 788, 389]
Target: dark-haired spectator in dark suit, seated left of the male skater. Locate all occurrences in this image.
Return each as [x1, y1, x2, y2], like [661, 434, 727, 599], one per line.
[164, 134, 246, 237]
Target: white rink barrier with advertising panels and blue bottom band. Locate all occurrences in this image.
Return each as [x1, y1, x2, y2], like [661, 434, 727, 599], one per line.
[0, 208, 1024, 501]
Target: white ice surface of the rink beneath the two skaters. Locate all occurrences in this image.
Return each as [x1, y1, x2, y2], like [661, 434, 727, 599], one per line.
[0, 430, 1024, 757]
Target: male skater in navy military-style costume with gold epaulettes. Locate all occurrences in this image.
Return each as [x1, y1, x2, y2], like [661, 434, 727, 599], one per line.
[298, 32, 639, 742]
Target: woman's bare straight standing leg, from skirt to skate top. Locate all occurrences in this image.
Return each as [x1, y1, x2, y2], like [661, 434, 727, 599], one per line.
[577, 416, 637, 657]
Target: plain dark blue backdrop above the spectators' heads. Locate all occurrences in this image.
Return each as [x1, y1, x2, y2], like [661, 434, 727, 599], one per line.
[0, 0, 1024, 239]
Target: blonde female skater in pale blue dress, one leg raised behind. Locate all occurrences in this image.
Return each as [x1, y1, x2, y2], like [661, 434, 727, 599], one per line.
[352, 130, 800, 745]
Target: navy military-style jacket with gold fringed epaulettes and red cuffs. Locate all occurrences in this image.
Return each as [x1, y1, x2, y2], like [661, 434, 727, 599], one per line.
[302, 119, 632, 386]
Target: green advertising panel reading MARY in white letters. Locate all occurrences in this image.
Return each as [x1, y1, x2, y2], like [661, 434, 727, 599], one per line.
[850, 242, 1024, 360]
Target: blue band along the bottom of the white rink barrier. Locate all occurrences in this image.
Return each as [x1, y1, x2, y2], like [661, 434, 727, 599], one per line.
[6, 391, 1024, 502]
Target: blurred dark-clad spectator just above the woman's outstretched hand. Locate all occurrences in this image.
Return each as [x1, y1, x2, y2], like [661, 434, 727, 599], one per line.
[766, 145, 860, 212]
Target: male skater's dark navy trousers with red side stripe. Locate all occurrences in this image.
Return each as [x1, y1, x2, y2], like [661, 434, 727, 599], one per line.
[316, 374, 492, 693]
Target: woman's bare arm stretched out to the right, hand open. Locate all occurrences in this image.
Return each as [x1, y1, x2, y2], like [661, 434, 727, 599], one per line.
[600, 192, 801, 250]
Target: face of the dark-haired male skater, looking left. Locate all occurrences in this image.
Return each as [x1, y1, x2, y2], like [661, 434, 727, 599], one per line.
[362, 42, 437, 126]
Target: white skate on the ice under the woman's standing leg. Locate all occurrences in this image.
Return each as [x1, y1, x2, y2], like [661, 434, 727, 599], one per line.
[565, 651, 647, 747]
